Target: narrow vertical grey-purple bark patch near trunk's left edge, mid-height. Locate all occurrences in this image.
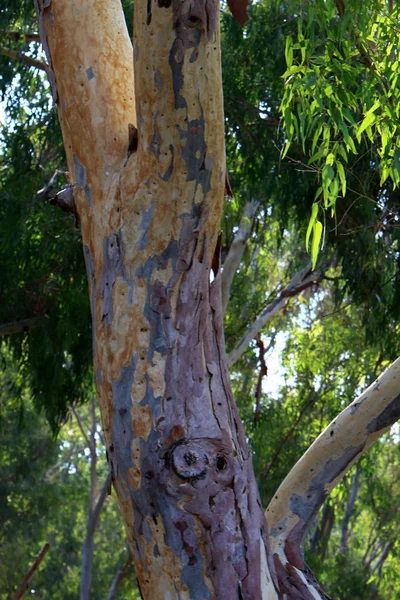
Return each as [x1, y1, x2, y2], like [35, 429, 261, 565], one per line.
[100, 231, 122, 325]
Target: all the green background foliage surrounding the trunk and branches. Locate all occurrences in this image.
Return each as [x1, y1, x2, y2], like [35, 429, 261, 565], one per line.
[0, 0, 400, 600]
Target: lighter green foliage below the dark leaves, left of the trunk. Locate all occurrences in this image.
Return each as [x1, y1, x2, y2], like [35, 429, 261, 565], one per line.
[0, 344, 138, 600]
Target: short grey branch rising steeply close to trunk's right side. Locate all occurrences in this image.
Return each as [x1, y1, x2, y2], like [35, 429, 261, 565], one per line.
[221, 202, 260, 314]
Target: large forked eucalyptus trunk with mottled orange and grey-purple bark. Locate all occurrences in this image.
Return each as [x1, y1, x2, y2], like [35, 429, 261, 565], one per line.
[38, 0, 278, 600]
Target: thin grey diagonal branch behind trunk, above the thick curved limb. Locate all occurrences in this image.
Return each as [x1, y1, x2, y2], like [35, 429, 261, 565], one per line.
[228, 260, 335, 367]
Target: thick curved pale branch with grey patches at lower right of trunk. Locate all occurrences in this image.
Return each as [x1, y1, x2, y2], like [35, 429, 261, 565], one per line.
[266, 358, 400, 598]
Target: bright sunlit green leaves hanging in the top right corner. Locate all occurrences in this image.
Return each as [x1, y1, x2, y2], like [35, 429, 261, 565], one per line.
[281, 0, 400, 265]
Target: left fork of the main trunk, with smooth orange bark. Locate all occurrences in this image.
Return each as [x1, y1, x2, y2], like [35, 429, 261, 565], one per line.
[35, 0, 136, 213]
